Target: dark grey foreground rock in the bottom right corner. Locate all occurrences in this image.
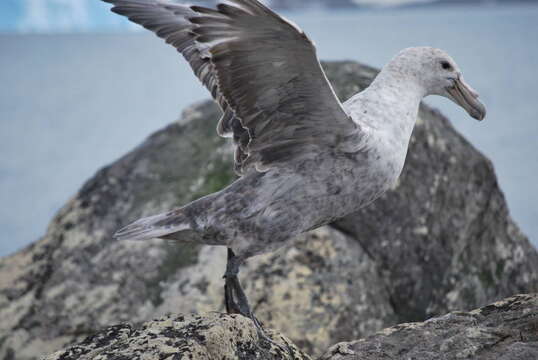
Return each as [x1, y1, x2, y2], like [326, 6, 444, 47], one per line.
[320, 294, 538, 360]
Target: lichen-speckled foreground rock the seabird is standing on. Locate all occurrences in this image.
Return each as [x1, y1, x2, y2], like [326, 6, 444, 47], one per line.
[44, 313, 310, 360]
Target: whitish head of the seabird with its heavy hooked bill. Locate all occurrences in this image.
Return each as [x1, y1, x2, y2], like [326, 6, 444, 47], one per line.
[387, 47, 486, 120]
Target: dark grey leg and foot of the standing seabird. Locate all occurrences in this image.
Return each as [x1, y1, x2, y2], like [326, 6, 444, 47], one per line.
[224, 248, 293, 355]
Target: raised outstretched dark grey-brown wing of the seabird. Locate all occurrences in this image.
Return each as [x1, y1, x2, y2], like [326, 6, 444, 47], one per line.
[104, 0, 357, 174]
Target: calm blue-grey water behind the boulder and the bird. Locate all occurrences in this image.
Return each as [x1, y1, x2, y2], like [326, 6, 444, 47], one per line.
[0, 5, 538, 256]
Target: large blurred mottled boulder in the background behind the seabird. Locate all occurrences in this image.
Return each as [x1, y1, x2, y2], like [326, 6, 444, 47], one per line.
[0, 62, 538, 360]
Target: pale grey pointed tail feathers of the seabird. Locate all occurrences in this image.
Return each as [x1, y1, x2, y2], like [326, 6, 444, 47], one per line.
[114, 209, 199, 241]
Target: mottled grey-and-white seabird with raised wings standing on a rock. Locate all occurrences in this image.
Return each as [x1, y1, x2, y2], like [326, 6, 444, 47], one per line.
[104, 0, 486, 344]
